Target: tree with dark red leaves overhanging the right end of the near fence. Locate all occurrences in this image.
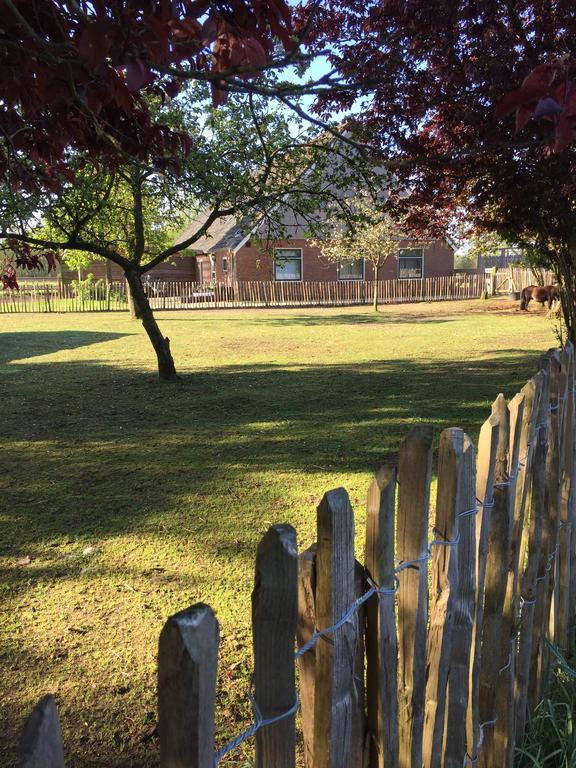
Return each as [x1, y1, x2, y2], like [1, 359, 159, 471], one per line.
[314, 0, 576, 340]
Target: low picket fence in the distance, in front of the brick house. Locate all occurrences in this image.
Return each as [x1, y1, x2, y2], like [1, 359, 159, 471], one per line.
[0, 274, 484, 313]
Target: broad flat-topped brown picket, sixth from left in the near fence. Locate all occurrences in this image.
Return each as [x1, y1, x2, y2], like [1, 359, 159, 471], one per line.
[397, 425, 433, 768]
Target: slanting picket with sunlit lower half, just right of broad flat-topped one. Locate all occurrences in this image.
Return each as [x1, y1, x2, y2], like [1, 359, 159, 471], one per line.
[418, 428, 464, 768]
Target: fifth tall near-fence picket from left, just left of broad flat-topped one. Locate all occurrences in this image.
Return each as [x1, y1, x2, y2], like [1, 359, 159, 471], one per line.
[365, 467, 398, 768]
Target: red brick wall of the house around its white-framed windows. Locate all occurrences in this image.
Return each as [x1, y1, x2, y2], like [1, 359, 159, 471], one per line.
[235, 240, 454, 281]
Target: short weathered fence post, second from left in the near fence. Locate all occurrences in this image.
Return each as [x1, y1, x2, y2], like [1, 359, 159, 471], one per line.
[158, 603, 218, 768]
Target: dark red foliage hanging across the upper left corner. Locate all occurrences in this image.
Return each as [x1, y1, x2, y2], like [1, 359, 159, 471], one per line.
[0, 0, 294, 190]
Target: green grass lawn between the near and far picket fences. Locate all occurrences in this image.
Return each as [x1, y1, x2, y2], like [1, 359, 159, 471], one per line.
[0, 301, 555, 768]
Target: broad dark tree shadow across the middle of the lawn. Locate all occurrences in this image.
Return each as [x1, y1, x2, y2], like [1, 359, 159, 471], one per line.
[0, 349, 536, 552]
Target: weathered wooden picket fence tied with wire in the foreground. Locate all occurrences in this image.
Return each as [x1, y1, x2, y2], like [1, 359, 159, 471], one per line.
[22, 345, 576, 768]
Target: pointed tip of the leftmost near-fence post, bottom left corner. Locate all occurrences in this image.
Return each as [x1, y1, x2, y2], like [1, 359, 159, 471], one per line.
[20, 695, 64, 768]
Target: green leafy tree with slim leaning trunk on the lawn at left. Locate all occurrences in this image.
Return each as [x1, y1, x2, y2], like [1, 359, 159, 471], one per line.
[0, 84, 385, 380]
